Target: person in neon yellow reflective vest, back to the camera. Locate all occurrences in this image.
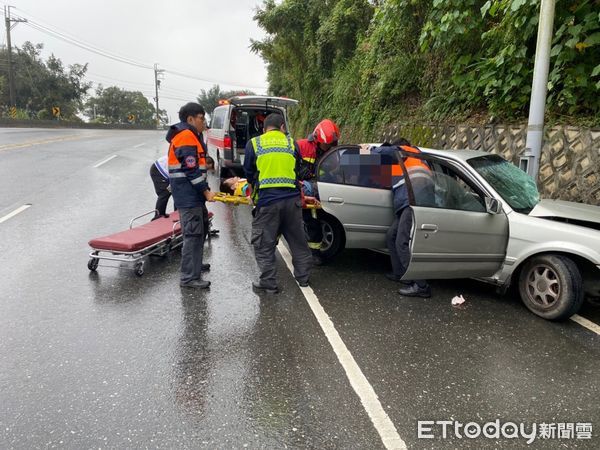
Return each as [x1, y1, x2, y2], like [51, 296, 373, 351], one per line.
[244, 113, 312, 293]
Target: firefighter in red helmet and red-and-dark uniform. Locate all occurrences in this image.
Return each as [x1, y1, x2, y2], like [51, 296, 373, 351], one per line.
[298, 119, 340, 265]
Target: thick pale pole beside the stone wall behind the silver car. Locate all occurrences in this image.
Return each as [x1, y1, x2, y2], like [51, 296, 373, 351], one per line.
[522, 0, 555, 182]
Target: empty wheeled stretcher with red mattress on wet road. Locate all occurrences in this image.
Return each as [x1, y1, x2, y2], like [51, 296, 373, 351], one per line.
[88, 210, 213, 277]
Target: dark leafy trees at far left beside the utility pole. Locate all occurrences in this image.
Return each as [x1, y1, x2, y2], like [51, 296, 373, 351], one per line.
[0, 42, 90, 120]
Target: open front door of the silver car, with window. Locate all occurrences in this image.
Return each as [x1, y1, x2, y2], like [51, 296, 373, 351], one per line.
[403, 155, 508, 280]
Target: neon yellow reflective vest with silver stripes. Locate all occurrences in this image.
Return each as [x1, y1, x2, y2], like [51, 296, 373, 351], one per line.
[252, 130, 296, 189]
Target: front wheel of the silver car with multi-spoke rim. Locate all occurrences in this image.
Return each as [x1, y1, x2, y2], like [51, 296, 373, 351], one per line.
[519, 255, 583, 320]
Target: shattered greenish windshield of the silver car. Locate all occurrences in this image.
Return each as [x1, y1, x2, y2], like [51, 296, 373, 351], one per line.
[468, 155, 540, 214]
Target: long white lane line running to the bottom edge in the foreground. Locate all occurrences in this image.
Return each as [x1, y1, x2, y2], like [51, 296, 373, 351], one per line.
[277, 242, 406, 450]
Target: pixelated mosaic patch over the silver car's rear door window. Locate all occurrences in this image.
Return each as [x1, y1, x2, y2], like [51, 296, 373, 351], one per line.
[340, 148, 393, 189]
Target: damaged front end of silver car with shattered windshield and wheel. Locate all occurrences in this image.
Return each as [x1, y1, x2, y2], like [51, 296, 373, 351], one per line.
[468, 155, 600, 320]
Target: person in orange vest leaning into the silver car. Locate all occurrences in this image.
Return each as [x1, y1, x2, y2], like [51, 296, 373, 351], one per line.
[373, 139, 433, 298]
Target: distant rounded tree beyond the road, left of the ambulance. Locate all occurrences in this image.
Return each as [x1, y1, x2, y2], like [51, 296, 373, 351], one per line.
[84, 86, 161, 126]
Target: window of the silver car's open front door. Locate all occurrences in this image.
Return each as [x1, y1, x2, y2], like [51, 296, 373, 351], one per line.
[422, 161, 486, 212]
